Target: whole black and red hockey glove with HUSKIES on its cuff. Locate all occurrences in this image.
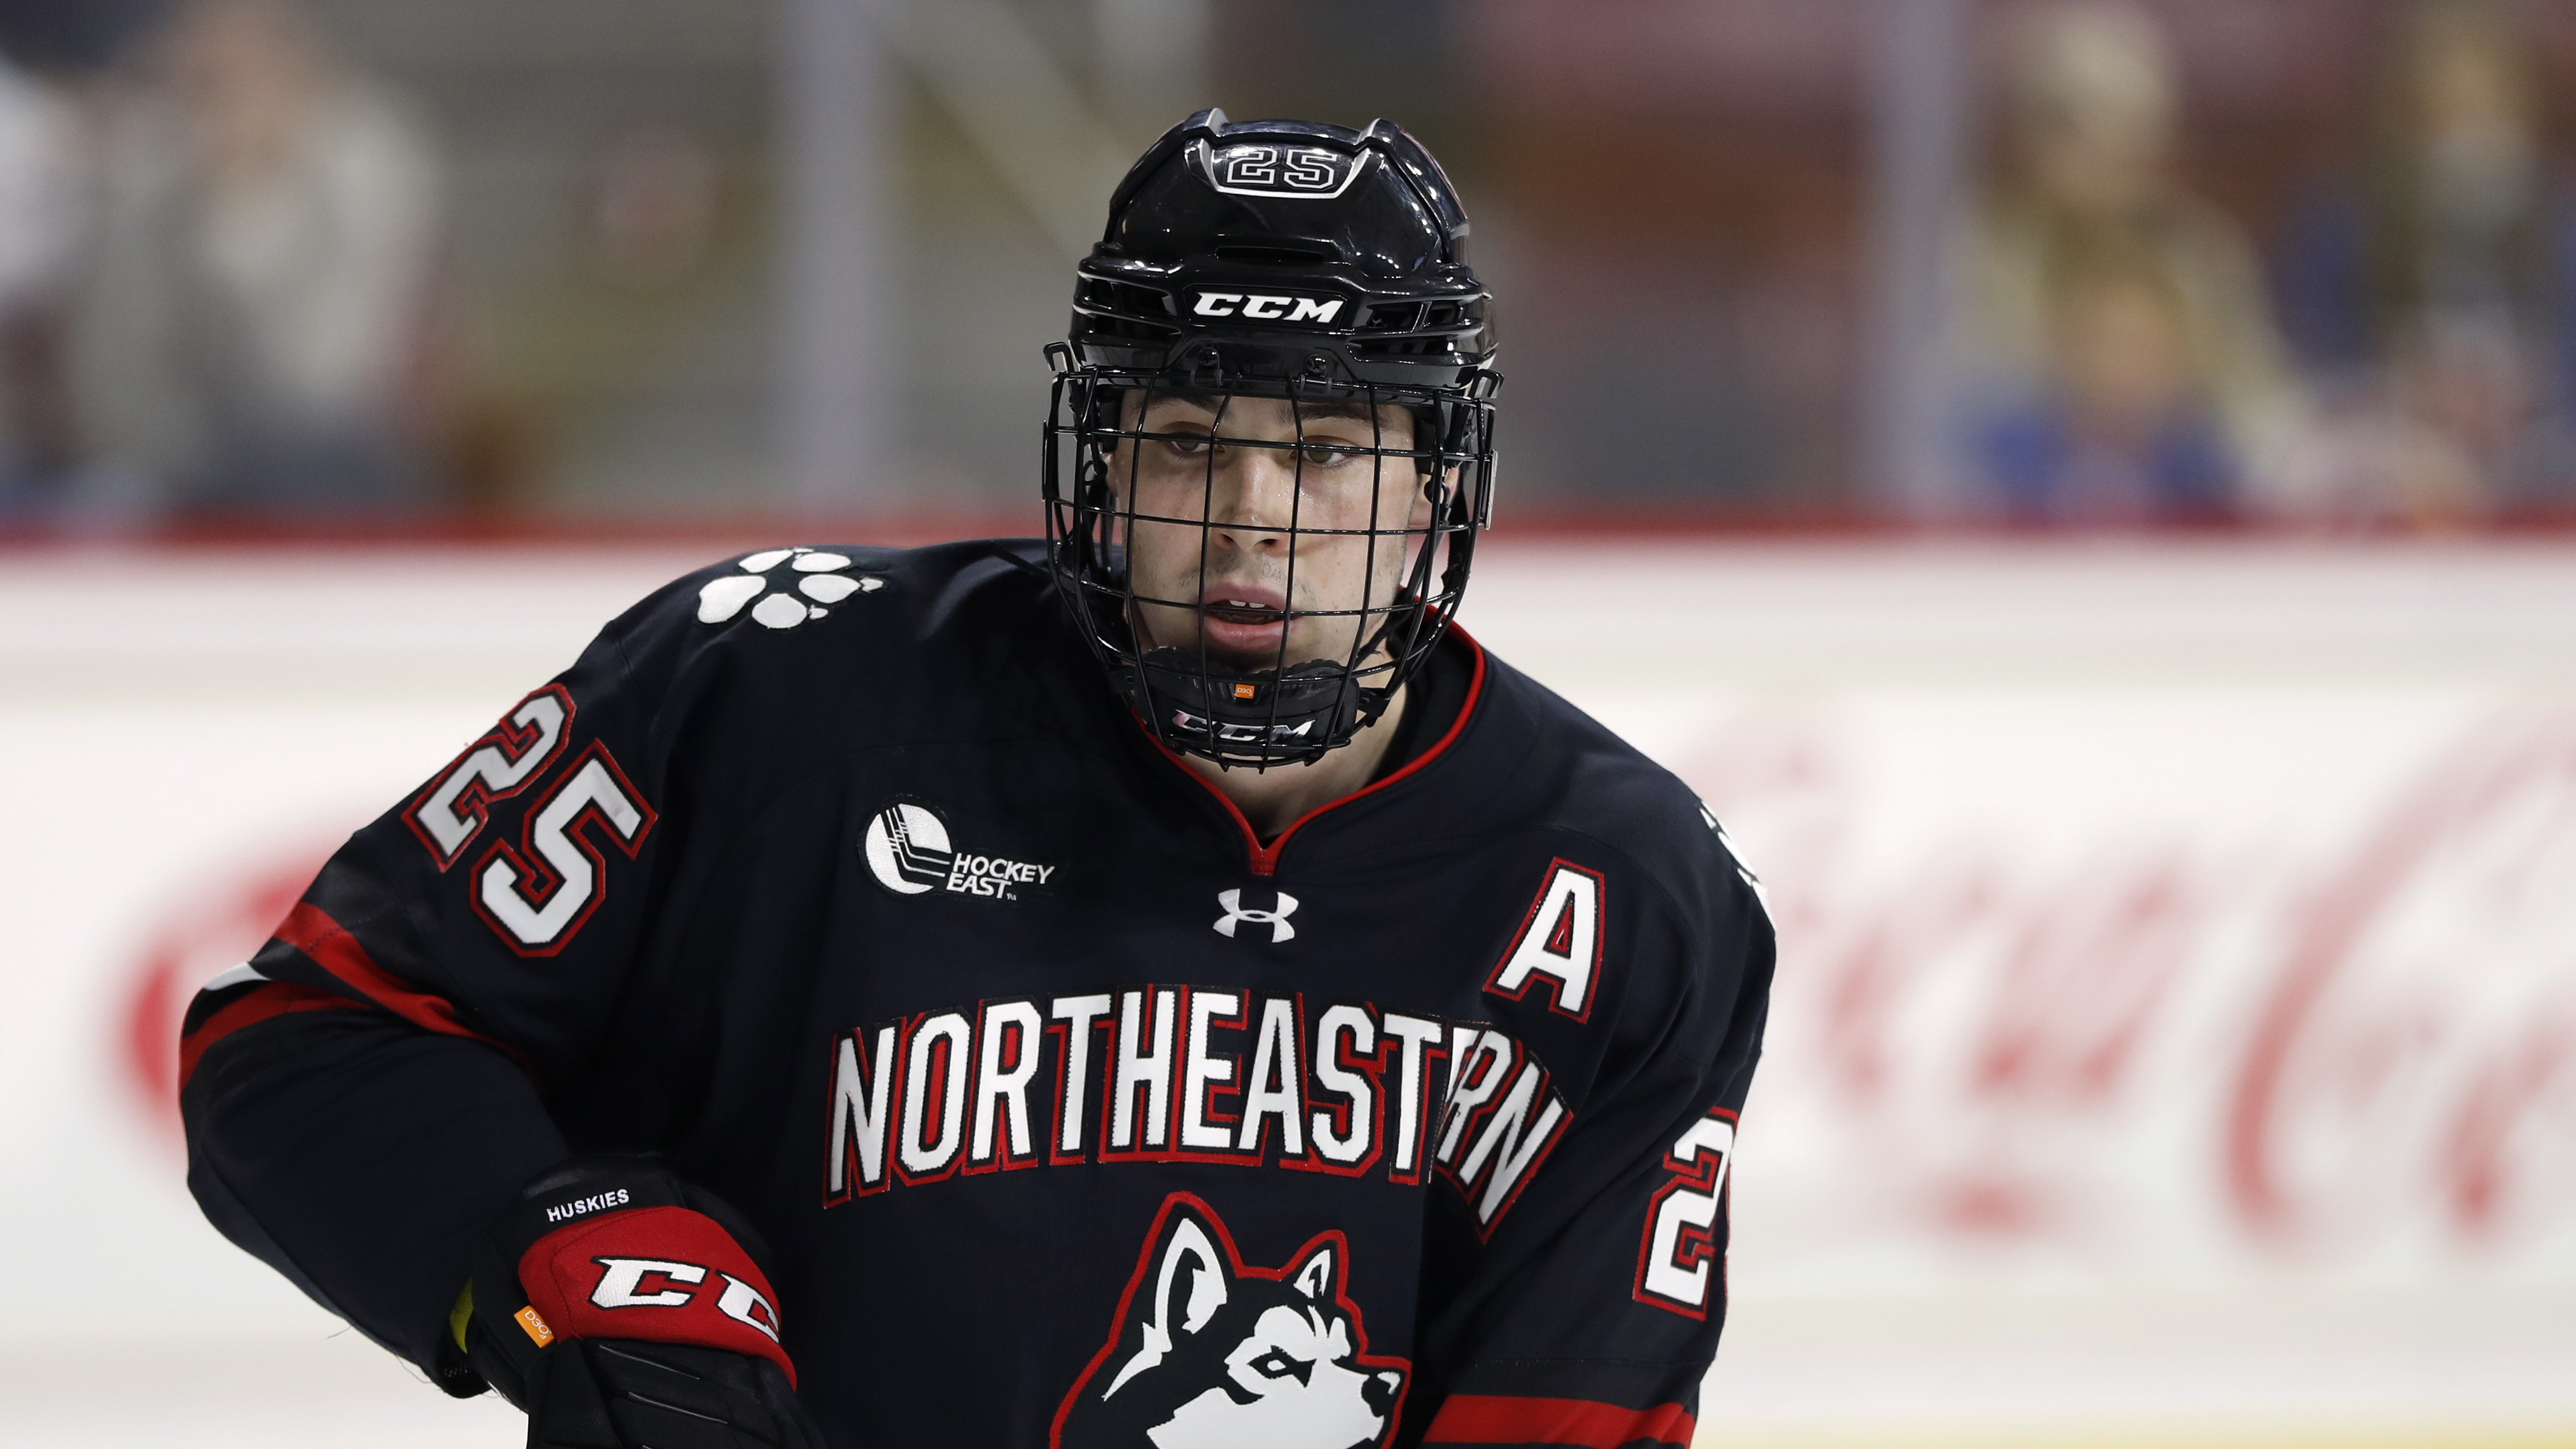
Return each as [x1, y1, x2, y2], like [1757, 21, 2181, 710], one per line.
[438, 1157, 825, 1449]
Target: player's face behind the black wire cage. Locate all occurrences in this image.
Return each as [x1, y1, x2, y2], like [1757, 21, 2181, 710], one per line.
[1110, 395, 1432, 670]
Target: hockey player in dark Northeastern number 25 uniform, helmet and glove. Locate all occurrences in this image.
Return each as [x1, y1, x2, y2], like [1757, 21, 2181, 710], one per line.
[180, 111, 1772, 1449]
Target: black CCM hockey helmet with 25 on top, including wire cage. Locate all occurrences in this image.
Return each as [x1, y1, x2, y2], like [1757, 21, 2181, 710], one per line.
[1044, 111, 1502, 769]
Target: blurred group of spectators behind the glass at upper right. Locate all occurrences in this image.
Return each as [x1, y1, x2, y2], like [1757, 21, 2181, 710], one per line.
[1958, 0, 2576, 526]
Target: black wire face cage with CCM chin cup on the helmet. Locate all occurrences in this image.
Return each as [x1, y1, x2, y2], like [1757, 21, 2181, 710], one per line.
[1044, 343, 1499, 771]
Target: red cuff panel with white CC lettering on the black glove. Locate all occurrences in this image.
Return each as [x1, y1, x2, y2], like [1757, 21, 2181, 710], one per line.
[518, 1207, 796, 1387]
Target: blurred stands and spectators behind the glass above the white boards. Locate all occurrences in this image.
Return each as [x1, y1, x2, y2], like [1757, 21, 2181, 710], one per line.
[0, 0, 2576, 531]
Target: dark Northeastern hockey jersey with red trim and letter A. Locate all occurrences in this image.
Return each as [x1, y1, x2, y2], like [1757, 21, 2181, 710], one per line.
[180, 544, 1772, 1449]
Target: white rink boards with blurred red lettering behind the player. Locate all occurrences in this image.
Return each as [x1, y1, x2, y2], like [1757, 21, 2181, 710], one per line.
[0, 542, 2576, 1449]
